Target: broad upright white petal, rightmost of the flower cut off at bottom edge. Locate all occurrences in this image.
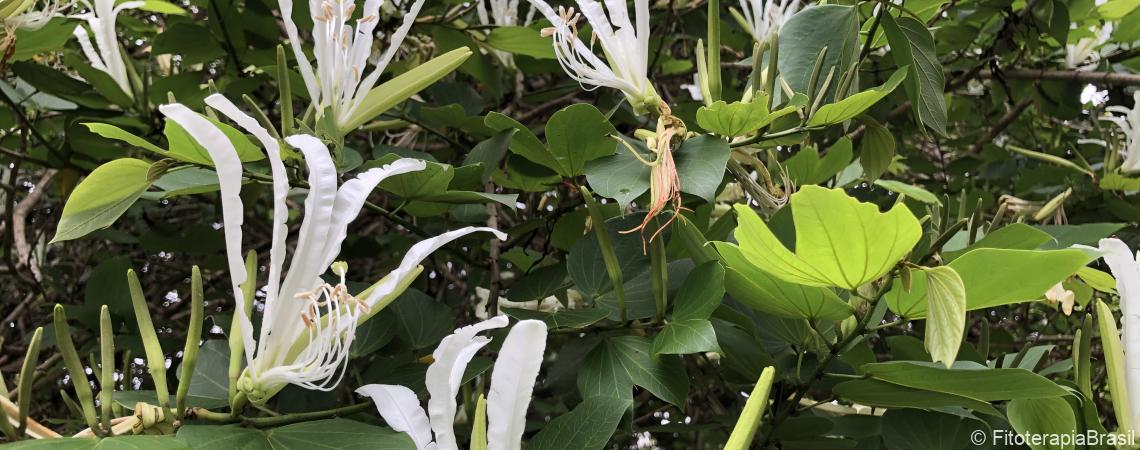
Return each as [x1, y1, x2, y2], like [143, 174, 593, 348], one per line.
[487, 320, 546, 450]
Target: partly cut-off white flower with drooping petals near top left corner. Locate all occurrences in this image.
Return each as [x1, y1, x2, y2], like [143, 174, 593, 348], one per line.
[75, 0, 144, 97]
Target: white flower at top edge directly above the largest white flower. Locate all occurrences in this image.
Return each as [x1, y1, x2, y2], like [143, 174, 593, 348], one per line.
[278, 0, 424, 130]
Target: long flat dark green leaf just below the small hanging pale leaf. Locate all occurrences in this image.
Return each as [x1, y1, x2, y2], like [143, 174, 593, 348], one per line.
[863, 361, 1068, 401]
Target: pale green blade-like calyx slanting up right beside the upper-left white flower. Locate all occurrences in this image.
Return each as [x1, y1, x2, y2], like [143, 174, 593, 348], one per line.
[339, 47, 471, 134]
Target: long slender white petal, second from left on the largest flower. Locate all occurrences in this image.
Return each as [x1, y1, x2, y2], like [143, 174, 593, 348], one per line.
[206, 93, 290, 353]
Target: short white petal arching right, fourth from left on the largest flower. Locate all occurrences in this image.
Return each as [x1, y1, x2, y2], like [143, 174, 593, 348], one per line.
[323, 158, 428, 267]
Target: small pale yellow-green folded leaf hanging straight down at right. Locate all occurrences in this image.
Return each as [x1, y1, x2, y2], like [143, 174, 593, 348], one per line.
[922, 265, 966, 368]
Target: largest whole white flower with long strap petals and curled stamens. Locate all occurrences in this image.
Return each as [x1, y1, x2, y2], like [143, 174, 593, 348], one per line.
[160, 95, 506, 404]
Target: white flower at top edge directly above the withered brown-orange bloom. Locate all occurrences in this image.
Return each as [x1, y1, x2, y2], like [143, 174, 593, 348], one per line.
[529, 0, 661, 113]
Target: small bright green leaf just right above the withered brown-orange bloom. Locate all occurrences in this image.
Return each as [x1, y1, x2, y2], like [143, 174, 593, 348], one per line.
[697, 92, 807, 138]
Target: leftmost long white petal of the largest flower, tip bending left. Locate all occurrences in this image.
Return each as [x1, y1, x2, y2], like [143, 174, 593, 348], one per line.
[158, 104, 254, 361]
